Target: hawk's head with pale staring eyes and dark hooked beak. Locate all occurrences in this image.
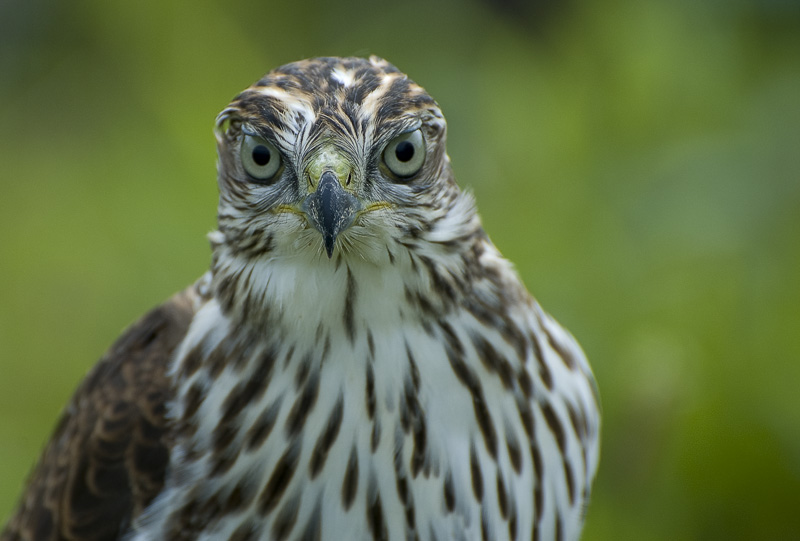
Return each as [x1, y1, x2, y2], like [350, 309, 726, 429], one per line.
[212, 57, 477, 268]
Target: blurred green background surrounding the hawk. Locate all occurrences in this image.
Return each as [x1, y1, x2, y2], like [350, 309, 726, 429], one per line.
[0, 0, 800, 540]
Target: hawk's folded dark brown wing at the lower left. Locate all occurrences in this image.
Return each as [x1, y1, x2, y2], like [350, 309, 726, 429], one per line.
[0, 288, 198, 541]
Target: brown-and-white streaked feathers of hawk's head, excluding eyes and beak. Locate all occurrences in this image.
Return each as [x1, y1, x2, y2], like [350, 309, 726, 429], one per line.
[212, 57, 457, 255]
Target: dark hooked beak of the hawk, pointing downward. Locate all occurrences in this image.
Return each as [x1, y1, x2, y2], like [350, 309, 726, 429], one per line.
[303, 171, 361, 259]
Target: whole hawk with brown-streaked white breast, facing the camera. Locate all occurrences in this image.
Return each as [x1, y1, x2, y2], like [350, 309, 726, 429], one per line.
[0, 56, 600, 541]
